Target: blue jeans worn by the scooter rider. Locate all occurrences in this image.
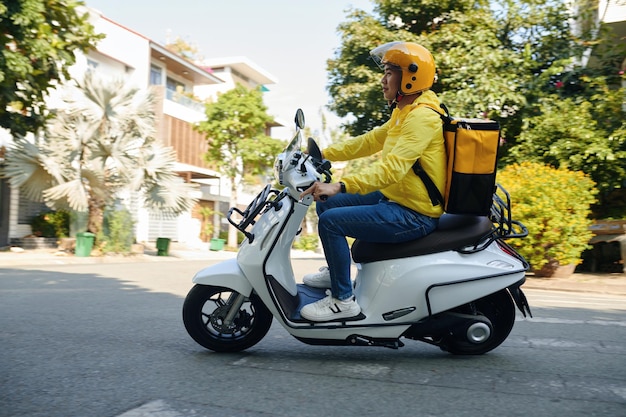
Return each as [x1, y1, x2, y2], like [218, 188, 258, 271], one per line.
[316, 191, 439, 300]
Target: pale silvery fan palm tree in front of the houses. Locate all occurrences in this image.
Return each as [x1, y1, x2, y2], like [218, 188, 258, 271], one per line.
[5, 72, 195, 234]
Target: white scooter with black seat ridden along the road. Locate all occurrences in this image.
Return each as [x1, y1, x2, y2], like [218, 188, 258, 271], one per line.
[183, 110, 530, 354]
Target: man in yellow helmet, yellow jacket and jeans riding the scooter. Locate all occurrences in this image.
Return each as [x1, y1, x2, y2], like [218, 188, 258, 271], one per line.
[300, 42, 446, 322]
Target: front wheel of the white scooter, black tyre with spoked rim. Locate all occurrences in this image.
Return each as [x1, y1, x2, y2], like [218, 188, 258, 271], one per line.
[183, 285, 272, 352]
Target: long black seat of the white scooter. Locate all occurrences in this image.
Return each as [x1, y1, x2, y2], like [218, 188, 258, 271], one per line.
[352, 214, 493, 263]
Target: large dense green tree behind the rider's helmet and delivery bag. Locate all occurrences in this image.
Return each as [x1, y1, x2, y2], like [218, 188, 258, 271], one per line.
[327, 0, 626, 216]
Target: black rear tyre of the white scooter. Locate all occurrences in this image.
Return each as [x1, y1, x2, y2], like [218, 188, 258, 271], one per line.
[440, 290, 515, 355]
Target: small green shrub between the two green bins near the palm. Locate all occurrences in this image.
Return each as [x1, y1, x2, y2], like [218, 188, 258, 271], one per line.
[98, 209, 135, 253]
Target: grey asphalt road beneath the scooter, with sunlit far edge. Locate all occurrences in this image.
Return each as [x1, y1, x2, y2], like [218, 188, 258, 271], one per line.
[0, 259, 626, 417]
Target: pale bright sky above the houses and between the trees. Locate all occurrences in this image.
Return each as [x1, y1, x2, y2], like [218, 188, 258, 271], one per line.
[85, 0, 373, 138]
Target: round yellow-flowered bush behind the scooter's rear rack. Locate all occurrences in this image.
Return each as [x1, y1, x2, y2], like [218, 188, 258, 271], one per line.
[498, 162, 597, 272]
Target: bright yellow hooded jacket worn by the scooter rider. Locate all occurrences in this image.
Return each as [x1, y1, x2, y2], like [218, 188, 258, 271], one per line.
[324, 90, 446, 218]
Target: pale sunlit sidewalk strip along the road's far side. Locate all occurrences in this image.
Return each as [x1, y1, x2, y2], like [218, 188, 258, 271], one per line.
[0, 244, 626, 296]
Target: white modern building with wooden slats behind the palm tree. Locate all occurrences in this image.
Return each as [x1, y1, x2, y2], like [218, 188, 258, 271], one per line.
[0, 9, 276, 246]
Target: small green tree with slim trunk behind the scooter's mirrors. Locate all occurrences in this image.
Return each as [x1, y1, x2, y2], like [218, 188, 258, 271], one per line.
[196, 84, 284, 247]
